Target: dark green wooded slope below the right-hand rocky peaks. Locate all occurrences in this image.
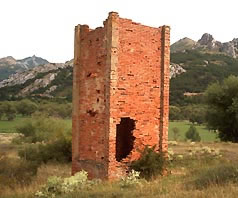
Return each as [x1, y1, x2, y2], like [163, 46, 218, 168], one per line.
[170, 50, 238, 105]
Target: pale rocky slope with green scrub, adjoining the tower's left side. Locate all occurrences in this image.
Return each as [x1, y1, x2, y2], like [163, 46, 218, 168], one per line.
[0, 60, 73, 99]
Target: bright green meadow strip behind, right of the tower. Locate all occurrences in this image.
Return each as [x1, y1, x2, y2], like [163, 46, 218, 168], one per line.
[169, 121, 218, 142]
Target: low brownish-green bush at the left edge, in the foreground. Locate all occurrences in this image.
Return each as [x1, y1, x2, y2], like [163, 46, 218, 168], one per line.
[0, 157, 38, 187]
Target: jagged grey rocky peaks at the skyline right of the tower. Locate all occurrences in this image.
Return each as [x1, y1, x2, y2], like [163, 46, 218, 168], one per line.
[171, 33, 238, 58]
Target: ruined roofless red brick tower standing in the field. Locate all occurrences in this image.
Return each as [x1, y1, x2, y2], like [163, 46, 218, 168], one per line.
[72, 12, 170, 179]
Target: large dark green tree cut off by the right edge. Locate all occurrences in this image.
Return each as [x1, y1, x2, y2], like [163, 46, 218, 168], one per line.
[205, 76, 238, 142]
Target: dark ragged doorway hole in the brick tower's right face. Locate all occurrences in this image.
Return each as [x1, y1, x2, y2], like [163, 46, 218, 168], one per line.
[116, 118, 135, 162]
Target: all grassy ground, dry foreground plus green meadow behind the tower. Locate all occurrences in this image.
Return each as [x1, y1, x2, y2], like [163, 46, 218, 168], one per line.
[0, 118, 238, 198]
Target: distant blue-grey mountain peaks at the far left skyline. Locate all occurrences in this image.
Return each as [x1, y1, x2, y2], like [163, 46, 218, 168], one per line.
[0, 55, 49, 81]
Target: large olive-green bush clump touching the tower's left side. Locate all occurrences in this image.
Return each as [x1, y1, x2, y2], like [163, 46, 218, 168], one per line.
[17, 114, 72, 164]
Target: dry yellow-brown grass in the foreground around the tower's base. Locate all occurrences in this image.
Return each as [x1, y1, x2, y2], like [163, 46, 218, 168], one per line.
[0, 138, 238, 198]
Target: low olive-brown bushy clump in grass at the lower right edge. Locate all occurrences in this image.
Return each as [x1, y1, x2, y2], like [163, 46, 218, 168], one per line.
[194, 165, 238, 189]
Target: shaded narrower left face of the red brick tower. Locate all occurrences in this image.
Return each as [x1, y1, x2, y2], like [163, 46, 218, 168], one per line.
[72, 26, 108, 177]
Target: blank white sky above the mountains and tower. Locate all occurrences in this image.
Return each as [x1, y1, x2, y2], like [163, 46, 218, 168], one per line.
[0, 0, 238, 62]
